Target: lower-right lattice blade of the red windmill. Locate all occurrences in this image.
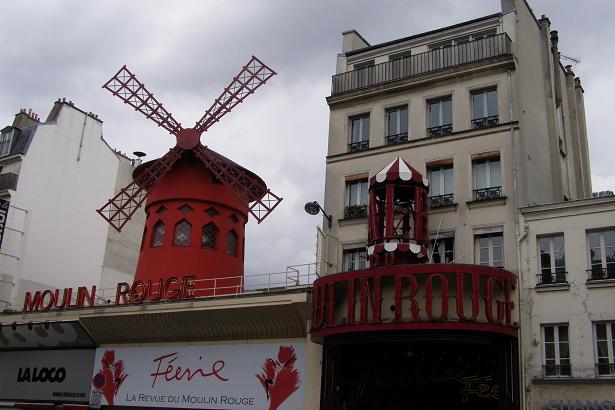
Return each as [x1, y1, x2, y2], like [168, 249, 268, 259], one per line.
[194, 145, 283, 224]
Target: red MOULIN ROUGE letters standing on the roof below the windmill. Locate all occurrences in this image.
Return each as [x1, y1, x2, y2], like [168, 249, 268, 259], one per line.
[23, 276, 195, 312]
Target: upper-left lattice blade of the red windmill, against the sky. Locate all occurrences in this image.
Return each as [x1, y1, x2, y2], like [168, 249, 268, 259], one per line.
[103, 66, 181, 135]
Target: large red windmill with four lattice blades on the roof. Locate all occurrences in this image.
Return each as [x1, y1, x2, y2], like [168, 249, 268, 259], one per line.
[98, 56, 282, 293]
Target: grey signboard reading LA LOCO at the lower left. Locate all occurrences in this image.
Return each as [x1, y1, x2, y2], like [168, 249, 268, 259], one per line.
[0, 349, 95, 402]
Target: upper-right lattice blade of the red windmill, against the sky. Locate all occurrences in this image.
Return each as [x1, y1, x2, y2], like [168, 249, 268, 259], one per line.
[194, 56, 277, 133]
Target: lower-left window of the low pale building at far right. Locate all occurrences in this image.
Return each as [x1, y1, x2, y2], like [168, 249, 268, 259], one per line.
[542, 325, 571, 376]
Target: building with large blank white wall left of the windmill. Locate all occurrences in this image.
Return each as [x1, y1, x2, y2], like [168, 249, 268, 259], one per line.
[0, 99, 145, 308]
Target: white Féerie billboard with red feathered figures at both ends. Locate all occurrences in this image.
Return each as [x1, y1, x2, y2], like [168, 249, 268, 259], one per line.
[90, 343, 305, 410]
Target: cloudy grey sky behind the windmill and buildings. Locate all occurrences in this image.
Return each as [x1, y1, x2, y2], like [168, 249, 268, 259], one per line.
[0, 0, 615, 273]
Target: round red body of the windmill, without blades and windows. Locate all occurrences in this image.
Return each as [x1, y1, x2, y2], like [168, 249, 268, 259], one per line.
[135, 152, 248, 296]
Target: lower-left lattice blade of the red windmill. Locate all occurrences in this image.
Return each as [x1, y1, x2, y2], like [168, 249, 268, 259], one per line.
[96, 147, 183, 232]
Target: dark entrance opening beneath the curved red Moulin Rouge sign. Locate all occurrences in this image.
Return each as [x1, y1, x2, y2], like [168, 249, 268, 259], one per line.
[321, 331, 519, 410]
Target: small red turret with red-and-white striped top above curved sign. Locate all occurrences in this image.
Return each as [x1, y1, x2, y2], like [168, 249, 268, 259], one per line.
[367, 158, 429, 267]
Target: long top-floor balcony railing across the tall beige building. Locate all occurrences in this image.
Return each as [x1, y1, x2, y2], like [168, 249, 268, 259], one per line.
[331, 33, 512, 96]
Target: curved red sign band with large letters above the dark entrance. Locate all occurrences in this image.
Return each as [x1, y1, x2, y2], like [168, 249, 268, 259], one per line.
[311, 264, 517, 338]
